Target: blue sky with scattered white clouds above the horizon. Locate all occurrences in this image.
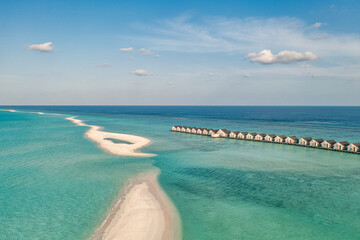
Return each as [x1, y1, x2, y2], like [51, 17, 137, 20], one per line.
[0, 0, 360, 106]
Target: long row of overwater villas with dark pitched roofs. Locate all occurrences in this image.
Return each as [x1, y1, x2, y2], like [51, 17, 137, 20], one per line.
[171, 126, 360, 154]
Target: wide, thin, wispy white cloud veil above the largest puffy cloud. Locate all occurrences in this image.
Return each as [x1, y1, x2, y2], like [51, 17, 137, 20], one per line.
[130, 15, 360, 58]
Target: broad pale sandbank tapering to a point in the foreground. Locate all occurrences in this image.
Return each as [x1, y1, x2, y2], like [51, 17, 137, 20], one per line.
[91, 172, 181, 240]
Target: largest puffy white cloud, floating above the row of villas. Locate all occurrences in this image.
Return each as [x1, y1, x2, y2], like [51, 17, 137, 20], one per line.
[246, 49, 318, 64]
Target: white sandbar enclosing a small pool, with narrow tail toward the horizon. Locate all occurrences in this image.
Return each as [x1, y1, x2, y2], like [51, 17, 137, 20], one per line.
[66, 117, 155, 157]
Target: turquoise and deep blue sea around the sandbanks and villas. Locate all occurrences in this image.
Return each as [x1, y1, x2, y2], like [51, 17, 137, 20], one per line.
[0, 106, 360, 240]
